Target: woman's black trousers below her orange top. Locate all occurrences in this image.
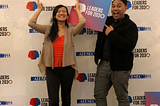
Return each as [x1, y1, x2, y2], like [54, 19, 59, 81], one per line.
[46, 66, 75, 106]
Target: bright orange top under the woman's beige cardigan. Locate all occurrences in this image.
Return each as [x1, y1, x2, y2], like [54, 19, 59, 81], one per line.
[53, 35, 64, 67]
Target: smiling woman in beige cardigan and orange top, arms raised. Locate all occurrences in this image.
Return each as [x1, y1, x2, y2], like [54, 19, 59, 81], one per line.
[28, 0, 86, 106]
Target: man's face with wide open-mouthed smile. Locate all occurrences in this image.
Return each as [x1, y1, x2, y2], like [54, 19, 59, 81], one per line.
[111, 0, 127, 20]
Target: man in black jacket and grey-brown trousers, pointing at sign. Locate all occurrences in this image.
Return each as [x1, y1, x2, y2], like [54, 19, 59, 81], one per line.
[94, 0, 138, 106]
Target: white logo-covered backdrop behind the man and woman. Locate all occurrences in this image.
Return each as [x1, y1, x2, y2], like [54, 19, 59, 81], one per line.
[0, 0, 160, 106]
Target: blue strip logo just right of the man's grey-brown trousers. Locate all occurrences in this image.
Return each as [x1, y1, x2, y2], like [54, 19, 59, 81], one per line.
[130, 74, 152, 79]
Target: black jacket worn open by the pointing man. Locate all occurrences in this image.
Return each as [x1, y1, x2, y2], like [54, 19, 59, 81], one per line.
[95, 14, 138, 71]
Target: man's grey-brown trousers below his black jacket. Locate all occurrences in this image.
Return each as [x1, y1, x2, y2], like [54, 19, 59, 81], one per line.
[94, 61, 131, 106]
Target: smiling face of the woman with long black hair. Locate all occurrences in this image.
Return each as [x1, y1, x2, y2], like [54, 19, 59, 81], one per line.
[55, 7, 68, 22]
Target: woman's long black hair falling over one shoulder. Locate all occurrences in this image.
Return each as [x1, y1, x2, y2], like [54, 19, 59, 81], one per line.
[48, 5, 69, 42]
